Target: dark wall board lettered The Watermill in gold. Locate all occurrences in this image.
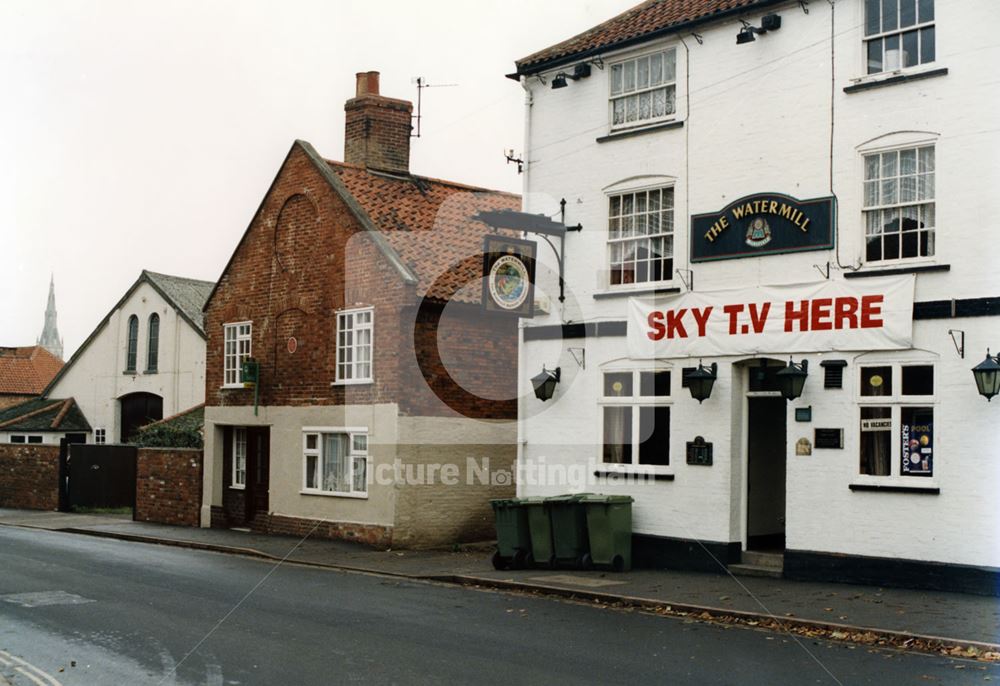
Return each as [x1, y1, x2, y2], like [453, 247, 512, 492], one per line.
[691, 193, 836, 262]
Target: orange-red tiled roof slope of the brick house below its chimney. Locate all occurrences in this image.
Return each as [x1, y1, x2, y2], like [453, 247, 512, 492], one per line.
[327, 161, 521, 303]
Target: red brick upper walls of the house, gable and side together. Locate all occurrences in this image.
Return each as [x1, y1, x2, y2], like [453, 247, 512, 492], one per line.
[205, 146, 517, 419]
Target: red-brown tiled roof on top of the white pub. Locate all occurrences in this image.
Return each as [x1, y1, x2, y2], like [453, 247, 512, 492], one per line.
[517, 0, 769, 74]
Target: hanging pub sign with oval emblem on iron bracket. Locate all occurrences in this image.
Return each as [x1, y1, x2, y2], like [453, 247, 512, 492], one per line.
[482, 235, 535, 318]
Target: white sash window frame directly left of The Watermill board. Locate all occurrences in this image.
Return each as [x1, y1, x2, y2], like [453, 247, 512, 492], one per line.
[604, 183, 677, 291]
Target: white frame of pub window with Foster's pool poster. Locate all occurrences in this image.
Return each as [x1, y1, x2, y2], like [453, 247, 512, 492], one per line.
[853, 359, 941, 488]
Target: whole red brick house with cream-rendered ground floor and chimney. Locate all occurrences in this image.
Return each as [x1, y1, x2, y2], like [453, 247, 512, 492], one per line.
[201, 72, 520, 547]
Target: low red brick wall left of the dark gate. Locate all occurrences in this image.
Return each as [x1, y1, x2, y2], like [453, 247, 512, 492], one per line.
[0, 444, 59, 510]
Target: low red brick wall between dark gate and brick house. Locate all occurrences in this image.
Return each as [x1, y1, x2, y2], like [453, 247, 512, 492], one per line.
[135, 448, 203, 526]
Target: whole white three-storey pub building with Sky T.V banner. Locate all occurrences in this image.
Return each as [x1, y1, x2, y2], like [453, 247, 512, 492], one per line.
[510, 0, 1000, 594]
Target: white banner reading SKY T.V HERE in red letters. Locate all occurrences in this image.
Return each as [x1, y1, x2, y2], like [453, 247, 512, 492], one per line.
[628, 274, 915, 359]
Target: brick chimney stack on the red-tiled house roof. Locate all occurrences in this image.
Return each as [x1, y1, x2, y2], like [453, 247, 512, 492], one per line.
[344, 71, 413, 174]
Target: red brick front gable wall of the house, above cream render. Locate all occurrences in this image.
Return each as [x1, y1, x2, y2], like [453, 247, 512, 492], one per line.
[205, 146, 412, 406]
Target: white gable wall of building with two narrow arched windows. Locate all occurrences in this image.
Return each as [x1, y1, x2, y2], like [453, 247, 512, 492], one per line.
[49, 283, 205, 443]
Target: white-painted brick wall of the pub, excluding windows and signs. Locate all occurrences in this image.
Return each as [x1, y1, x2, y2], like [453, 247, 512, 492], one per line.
[519, 0, 1000, 567]
